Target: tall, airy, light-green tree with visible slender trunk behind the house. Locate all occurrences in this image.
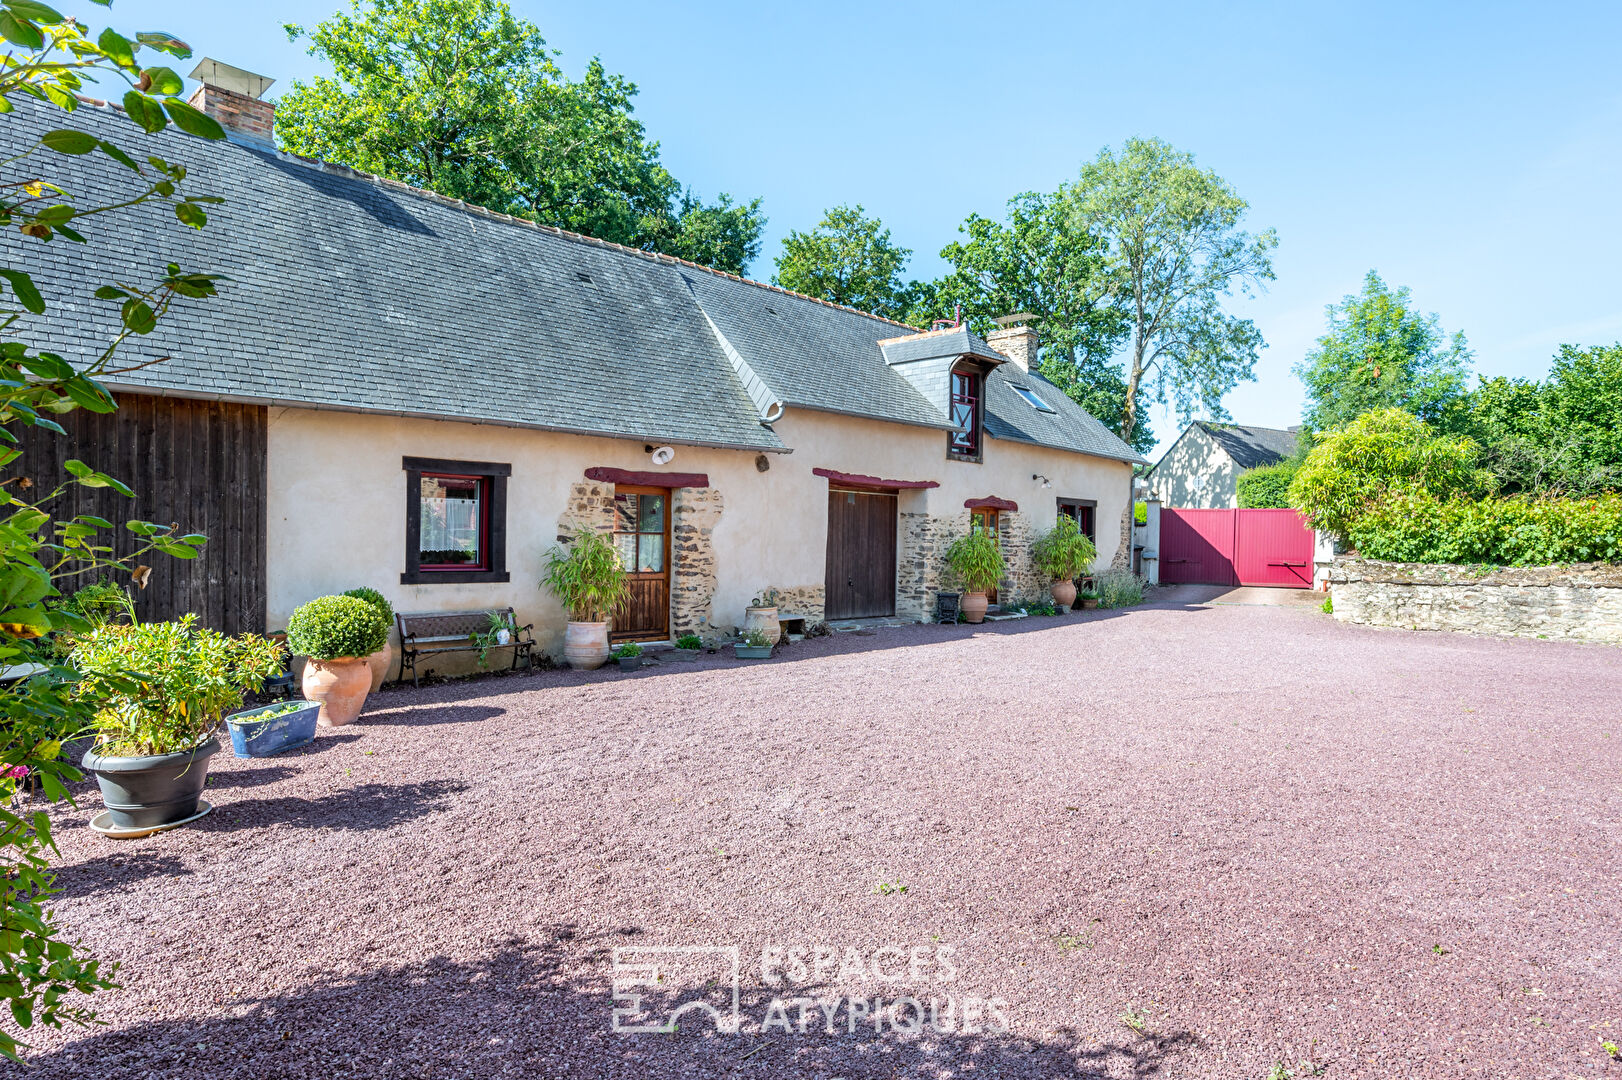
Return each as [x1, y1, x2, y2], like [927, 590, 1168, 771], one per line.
[1069, 139, 1278, 441]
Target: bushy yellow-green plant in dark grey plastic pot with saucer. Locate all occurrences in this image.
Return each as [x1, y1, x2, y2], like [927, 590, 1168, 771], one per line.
[73, 615, 282, 830]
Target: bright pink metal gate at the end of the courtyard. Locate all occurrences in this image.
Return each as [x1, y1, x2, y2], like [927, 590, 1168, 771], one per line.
[1160, 509, 1312, 589]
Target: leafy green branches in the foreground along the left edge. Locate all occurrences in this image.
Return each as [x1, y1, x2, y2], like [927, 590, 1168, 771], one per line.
[0, 0, 224, 1059]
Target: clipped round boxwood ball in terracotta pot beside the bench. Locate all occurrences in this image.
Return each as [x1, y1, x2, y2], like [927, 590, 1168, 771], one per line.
[287, 597, 389, 728]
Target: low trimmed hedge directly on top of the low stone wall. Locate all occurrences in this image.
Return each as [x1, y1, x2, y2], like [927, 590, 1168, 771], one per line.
[1348, 491, 1622, 566]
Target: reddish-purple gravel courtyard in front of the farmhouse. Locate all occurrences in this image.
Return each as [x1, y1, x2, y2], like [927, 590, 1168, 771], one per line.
[18, 603, 1622, 1080]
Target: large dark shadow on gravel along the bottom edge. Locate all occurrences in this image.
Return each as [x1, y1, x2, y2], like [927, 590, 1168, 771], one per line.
[19, 928, 1194, 1080]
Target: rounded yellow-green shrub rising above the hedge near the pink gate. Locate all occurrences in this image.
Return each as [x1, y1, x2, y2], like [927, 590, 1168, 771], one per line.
[1288, 409, 1492, 540]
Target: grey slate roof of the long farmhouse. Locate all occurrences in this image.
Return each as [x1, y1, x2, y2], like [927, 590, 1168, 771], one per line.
[0, 93, 1140, 461]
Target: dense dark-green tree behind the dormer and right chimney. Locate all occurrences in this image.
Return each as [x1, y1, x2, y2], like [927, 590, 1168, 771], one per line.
[907, 186, 1155, 451]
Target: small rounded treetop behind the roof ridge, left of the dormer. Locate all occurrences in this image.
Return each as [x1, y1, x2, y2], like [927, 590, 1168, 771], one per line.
[772, 204, 912, 318]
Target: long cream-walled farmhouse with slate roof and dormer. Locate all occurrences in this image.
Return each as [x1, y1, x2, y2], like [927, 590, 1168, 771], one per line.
[15, 63, 1144, 652]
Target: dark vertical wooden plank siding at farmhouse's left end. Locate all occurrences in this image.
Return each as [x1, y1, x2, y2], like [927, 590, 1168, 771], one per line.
[6, 394, 266, 634]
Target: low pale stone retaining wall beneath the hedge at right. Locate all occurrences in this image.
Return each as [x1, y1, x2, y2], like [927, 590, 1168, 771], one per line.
[1328, 558, 1622, 645]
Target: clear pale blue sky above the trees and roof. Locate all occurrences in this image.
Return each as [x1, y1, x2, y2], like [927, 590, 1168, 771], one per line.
[98, 0, 1622, 448]
